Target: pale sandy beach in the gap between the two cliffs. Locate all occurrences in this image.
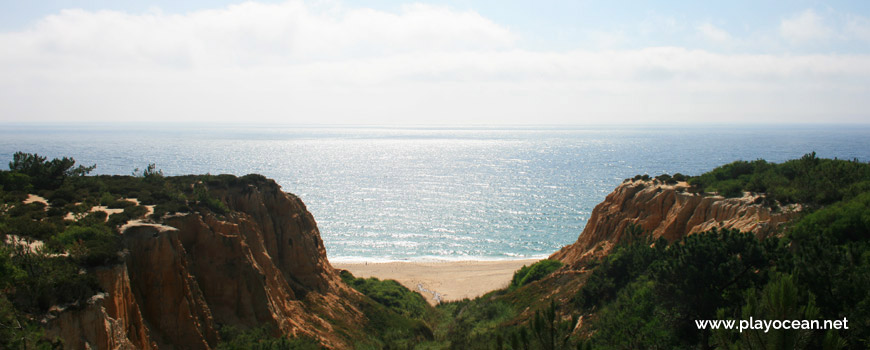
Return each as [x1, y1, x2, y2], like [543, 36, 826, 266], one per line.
[332, 259, 538, 305]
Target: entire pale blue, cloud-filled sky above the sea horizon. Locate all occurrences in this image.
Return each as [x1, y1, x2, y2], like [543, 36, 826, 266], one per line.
[0, 0, 870, 125]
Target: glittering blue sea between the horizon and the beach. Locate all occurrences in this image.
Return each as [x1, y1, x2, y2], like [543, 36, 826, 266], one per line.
[0, 124, 870, 261]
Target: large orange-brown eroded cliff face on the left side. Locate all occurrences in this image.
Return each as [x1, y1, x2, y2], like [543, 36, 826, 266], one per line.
[47, 181, 365, 349]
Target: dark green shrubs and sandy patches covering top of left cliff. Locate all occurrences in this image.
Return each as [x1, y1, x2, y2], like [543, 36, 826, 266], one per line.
[0, 153, 338, 349]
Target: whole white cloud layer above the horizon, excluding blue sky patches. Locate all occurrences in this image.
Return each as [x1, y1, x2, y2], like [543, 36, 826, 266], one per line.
[0, 2, 870, 124]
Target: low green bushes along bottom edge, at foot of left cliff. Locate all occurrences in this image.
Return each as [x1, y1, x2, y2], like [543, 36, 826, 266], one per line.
[217, 325, 323, 350]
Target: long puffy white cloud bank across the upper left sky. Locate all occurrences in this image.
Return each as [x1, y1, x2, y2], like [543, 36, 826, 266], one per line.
[5, 1, 514, 66]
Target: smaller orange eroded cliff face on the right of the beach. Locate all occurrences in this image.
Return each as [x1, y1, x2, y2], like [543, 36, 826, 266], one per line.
[550, 181, 800, 268]
